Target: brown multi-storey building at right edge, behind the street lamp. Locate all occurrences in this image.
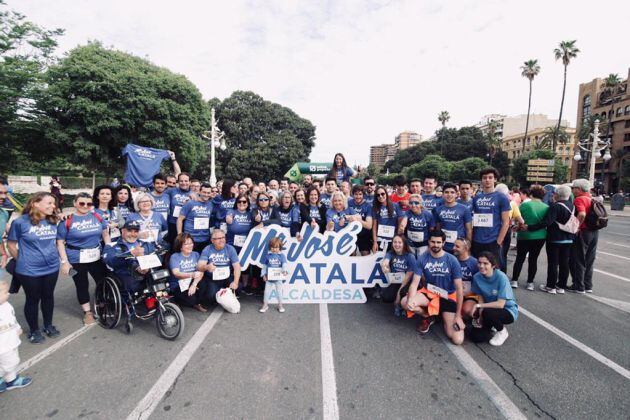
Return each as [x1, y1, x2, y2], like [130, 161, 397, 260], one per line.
[571, 69, 630, 193]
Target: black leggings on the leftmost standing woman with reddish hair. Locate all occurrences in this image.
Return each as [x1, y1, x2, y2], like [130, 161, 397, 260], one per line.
[15, 271, 59, 332]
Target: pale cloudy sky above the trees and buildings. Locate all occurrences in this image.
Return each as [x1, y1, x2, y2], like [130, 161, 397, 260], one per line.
[7, 0, 630, 164]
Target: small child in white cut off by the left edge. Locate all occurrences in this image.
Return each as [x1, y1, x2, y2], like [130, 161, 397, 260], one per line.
[0, 278, 31, 392]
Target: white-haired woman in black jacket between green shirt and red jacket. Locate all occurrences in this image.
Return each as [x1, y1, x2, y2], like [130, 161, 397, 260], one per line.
[527, 185, 575, 295]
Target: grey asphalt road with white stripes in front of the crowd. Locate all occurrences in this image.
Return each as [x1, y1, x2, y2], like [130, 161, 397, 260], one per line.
[0, 217, 630, 419]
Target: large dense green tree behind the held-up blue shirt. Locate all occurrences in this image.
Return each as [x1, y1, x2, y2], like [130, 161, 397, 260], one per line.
[38, 42, 210, 173]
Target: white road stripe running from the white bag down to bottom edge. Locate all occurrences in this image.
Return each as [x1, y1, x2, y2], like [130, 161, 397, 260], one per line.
[127, 306, 223, 420]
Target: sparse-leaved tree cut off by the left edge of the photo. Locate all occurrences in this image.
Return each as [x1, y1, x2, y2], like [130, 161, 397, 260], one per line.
[0, 0, 63, 172]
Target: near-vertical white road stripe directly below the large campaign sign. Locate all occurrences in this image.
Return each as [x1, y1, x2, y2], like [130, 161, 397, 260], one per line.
[319, 303, 339, 420]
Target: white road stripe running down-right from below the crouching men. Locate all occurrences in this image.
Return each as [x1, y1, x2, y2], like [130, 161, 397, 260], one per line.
[439, 334, 527, 419]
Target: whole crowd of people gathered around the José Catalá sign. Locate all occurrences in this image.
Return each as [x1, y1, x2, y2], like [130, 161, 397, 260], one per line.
[0, 154, 612, 394]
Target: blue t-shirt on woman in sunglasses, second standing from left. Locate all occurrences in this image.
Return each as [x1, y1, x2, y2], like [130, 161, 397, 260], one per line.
[57, 212, 109, 264]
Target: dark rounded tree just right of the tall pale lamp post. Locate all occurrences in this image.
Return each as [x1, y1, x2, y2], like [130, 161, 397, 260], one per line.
[213, 91, 316, 180]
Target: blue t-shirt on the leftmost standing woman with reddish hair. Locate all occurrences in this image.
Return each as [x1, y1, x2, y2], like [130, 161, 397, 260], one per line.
[7, 214, 59, 277]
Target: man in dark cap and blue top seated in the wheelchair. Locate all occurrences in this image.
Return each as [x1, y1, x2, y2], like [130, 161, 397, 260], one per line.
[103, 221, 156, 299]
